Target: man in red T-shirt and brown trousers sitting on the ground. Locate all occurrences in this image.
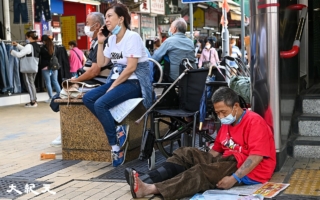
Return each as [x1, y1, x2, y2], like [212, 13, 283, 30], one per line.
[126, 87, 276, 199]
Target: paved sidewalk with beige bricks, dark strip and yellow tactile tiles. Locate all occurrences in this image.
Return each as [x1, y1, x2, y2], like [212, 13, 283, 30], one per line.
[0, 102, 320, 200]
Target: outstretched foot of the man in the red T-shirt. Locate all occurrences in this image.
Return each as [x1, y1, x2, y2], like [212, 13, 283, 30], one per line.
[133, 171, 159, 198]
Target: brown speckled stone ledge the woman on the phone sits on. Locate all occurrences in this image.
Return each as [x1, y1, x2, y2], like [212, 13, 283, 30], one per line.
[56, 99, 145, 162]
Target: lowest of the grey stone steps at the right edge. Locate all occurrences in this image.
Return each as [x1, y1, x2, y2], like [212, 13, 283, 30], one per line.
[293, 136, 320, 158]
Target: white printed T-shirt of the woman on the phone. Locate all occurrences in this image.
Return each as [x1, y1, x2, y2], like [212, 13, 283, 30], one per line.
[104, 30, 148, 79]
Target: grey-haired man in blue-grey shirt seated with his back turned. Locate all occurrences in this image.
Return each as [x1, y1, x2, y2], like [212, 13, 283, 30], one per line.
[152, 18, 196, 82]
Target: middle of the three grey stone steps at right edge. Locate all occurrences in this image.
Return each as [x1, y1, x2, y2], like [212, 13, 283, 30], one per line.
[298, 113, 320, 136]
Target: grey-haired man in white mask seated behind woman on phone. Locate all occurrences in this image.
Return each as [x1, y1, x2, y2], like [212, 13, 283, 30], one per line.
[72, 12, 110, 84]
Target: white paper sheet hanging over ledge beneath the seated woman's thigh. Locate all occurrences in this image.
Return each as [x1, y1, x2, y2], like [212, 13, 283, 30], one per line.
[110, 98, 143, 123]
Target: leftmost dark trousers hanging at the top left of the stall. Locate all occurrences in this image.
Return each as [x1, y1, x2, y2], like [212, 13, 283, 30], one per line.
[13, 0, 28, 24]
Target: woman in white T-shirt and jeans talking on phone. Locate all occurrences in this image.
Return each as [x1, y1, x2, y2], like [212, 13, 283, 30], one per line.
[83, 3, 152, 167]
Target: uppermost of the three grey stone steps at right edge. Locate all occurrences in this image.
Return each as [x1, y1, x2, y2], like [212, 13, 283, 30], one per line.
[302, 94, 320, 114]
